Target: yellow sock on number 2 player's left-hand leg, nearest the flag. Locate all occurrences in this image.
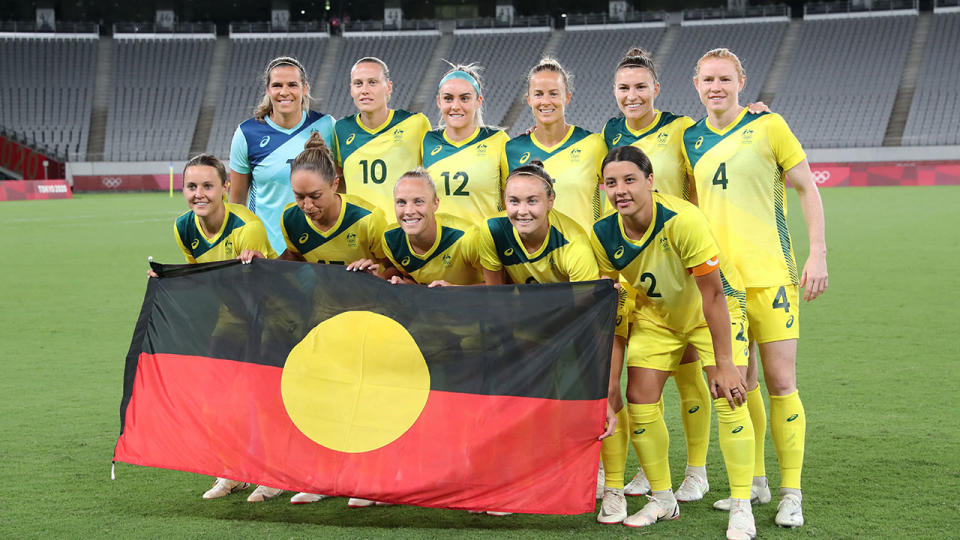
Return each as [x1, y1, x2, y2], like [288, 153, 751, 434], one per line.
[627, 403, 673, 491]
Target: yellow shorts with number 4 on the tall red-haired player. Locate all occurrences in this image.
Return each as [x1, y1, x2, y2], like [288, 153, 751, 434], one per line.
[747, 285, 800, 343]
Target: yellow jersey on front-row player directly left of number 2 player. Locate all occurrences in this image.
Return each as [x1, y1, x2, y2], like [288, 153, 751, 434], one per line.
[476, 210, 600, 283]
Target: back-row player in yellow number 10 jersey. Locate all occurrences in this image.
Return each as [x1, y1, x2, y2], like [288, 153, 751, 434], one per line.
[334, 56, 430, 221]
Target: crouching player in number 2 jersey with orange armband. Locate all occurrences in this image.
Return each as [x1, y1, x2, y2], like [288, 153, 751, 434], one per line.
[591, 146, 756, 538]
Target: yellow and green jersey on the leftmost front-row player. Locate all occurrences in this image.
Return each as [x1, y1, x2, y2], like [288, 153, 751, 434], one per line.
[173, 203, 277, 264]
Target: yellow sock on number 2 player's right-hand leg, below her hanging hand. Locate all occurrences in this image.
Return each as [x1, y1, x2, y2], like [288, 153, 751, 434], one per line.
[713, 398, 753, 499]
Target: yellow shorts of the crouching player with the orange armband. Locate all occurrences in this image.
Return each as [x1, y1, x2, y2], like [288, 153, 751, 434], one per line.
[627, 317, 749, 371]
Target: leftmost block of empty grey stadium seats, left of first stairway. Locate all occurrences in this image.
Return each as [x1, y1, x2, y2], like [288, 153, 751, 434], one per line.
[0, 35, 98, 161]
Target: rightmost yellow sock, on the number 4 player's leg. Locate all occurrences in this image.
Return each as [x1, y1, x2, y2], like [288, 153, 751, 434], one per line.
[770, 392, 807, 489]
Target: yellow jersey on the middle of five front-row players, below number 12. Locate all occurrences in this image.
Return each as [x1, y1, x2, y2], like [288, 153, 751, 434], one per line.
[383, 214, 483, 285]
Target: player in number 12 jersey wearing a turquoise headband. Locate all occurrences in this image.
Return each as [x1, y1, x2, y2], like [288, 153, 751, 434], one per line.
[421, 64, 510, 224]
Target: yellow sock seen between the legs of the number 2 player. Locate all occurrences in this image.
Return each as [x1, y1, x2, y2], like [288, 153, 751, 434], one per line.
[676, 361, 712, 467]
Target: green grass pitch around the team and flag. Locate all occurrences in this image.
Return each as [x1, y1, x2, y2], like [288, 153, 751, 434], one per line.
[0, 187, 960, 538]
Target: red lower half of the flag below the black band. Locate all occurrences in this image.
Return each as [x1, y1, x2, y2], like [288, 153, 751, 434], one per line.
[114, 353, 606, 514]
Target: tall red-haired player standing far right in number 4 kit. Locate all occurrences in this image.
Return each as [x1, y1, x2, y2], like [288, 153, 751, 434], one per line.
[683, 49, 827, 527]
